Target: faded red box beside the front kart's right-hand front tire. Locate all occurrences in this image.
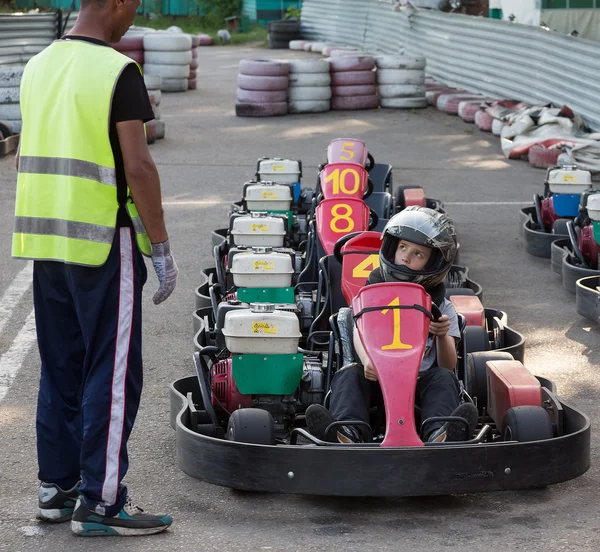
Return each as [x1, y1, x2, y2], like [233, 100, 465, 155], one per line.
[486, 360, 542, 431]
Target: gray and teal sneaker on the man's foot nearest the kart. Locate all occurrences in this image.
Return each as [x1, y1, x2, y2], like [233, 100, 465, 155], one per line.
[71, 497, 173, 537]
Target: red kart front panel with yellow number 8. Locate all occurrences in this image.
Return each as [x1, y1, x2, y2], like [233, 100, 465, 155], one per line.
[316, 198, 370, 255]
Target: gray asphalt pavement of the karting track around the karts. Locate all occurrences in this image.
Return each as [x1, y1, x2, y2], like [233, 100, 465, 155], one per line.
[0, 47, 600, 552]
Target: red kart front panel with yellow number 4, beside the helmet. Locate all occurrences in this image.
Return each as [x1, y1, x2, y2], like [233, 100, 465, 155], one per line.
[341, 232, 381, 305]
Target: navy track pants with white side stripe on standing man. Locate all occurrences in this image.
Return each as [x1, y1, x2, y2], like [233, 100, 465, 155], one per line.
[33, 228, 147, 516]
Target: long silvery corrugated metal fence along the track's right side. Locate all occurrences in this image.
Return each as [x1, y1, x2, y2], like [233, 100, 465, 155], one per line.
[302, 0, 600, 130]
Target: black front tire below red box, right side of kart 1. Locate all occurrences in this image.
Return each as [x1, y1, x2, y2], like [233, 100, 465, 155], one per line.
[496, 406, 554, 443]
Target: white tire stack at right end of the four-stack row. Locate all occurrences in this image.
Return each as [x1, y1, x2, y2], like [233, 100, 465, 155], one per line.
[375, 55, 427, 109]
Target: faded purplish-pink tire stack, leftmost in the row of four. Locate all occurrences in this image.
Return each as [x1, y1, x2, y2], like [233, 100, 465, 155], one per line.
[235, 60, 290, 117]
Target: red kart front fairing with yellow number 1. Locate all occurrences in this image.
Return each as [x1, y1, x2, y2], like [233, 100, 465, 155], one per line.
[352, 283, 431, 447]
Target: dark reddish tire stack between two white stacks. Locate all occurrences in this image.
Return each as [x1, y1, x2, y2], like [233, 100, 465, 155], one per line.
[328, 55, 379, 111]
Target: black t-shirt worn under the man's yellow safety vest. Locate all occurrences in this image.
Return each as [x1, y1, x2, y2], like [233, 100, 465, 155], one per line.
[63, 35, 154, 227]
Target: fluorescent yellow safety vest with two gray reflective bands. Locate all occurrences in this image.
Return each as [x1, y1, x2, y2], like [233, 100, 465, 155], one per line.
[12, 40, 152, 266]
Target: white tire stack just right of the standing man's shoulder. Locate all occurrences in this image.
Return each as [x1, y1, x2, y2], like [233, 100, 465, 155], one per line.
[144, 32, 192, 92]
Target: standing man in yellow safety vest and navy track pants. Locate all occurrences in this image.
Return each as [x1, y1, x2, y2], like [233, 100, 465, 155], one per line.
[12, 0, 178, 536]
